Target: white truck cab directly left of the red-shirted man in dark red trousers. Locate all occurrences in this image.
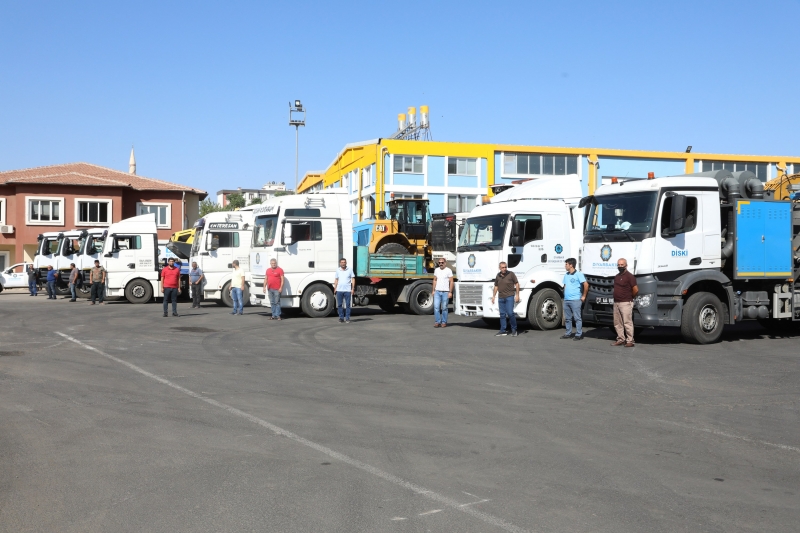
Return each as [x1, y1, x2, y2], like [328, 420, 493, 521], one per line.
[101, 213, 163, 303]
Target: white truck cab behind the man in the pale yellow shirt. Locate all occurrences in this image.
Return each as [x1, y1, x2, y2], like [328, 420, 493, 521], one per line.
[189, 208, 253, 307]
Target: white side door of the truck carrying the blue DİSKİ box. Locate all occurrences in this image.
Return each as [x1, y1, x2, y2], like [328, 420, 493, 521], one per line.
[655, 194, 704, 270]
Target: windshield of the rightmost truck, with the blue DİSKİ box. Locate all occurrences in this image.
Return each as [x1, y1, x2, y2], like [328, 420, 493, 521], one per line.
[586, 191, 658, 234]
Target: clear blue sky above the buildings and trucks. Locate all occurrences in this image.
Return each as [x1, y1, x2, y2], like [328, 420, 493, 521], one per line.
[0, 0, 800, 193]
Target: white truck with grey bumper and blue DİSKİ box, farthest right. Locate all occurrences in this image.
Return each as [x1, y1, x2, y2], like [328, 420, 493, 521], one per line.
[581, 170, 800, 344]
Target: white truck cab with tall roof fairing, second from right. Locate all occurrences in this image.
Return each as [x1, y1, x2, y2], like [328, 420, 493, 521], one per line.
[454, 175, 583, 330]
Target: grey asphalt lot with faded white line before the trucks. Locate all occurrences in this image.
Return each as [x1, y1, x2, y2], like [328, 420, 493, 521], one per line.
[0, 291, 800, 533]
